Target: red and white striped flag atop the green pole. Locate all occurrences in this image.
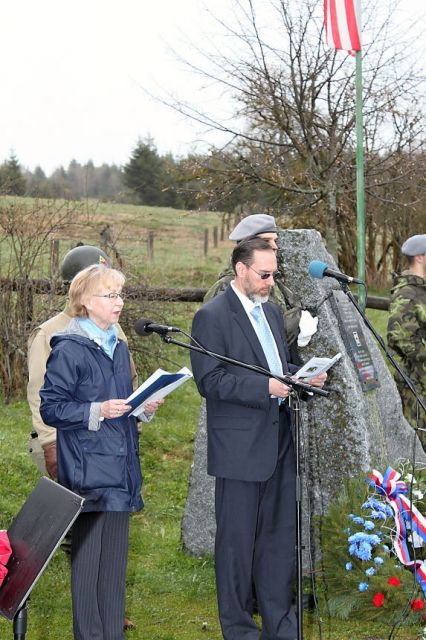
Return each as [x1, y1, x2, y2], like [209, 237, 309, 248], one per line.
[324, 0, 361, 54]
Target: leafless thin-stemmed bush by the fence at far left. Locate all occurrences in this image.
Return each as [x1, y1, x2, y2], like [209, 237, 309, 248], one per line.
[0, 197, 91, 402]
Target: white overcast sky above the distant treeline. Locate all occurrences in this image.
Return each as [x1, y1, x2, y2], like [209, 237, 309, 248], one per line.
[0, 0, 424, 174]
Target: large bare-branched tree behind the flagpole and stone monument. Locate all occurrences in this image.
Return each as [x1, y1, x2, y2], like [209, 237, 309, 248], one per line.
[163, 0, 425, 274]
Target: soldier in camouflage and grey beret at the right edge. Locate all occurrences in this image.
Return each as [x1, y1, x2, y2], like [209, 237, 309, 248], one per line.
[388, 234, 426, 451]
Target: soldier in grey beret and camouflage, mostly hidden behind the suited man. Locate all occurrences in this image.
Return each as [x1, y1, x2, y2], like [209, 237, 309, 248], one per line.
[204, 213, 316, 364]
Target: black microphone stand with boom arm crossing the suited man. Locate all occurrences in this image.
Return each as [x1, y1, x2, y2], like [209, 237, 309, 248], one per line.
[160, 331, 330, 640]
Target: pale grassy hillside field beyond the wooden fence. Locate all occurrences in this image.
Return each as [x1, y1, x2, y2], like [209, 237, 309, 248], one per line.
[0, 199, 232, 287]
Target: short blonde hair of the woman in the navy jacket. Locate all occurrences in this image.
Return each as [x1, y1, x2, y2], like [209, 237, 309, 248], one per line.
[69, 264, 126, 318]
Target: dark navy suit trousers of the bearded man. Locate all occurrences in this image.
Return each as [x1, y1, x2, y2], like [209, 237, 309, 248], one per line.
[215, 412, 297, 640]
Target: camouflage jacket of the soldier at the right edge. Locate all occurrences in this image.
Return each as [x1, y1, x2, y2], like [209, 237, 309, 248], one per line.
[388, 272, 426, 395]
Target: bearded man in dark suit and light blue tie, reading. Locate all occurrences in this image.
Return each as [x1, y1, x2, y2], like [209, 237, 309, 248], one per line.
[191, 238, 326, 640]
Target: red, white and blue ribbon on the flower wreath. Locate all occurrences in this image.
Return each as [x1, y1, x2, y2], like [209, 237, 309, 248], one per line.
[370, 467, 426, 596]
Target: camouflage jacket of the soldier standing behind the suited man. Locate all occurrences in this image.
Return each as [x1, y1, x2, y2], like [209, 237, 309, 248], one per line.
[204, 266, 302, 350]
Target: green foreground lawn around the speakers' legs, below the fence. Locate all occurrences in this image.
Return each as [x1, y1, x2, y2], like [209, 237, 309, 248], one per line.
[0, 383, 419, 640]
